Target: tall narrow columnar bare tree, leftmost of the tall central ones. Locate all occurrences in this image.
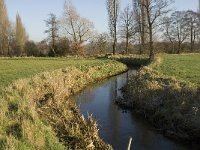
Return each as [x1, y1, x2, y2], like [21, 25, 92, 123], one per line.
[106, 0, 120, 54]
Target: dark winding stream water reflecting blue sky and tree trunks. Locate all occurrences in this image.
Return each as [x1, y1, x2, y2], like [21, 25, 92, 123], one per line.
[75, 70, 190, 150]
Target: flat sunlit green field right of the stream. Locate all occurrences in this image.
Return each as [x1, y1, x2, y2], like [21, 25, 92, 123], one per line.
[155, 54, 200, 85]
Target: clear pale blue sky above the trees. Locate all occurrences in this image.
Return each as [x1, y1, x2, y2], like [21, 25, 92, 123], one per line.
[5, 0, 198, 41]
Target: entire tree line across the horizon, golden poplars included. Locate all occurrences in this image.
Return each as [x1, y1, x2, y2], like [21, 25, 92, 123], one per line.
[0, 0, 200, 60]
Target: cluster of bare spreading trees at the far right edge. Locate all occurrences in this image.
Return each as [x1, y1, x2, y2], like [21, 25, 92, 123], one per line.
[162, 11, 200, 54]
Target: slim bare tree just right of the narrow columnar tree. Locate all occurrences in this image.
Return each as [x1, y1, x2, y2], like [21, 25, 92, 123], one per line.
[119, 5, 134, 54]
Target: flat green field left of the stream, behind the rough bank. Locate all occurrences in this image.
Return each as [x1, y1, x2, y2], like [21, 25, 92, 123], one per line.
[0, 58, 111, 89]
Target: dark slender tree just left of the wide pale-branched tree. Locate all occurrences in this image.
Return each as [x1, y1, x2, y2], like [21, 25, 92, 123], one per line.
[45, 13, 59, 56]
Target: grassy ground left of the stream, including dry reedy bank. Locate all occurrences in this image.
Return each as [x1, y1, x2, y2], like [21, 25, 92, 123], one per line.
[0, 59, 127, 150]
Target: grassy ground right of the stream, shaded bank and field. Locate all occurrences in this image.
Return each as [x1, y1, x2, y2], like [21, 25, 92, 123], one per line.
[118, 55, 200, 147]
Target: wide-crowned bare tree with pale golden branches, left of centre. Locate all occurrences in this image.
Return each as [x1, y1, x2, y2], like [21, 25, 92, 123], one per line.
[62, 0, 94, 54]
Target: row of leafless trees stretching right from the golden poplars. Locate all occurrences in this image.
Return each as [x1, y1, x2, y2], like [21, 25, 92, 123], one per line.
[45, 0, 200, 60]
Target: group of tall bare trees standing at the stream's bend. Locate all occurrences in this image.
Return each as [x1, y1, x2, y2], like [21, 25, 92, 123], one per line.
[107, 0, 171, 60]
